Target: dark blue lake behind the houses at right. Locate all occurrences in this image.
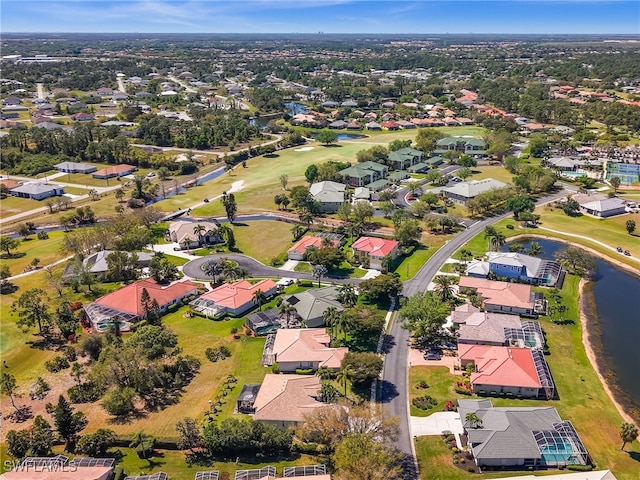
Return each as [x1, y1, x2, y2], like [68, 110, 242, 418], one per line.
[505, 238, 640, 420]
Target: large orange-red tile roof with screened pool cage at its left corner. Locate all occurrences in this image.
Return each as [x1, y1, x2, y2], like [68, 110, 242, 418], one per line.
[95, 278, 198, 316]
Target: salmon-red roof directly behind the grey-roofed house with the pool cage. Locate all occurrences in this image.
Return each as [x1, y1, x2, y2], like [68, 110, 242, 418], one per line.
[458, 344, 542, 388]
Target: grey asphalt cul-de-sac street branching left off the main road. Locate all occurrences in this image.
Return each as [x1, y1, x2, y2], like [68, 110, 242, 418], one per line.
[182, 253, 362, 283]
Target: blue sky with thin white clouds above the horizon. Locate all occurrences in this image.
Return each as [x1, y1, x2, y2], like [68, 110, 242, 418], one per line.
[0, 0, 640, 34]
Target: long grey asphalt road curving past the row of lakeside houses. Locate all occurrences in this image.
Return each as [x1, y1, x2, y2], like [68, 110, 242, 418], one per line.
[380, 188, 565, 479]
